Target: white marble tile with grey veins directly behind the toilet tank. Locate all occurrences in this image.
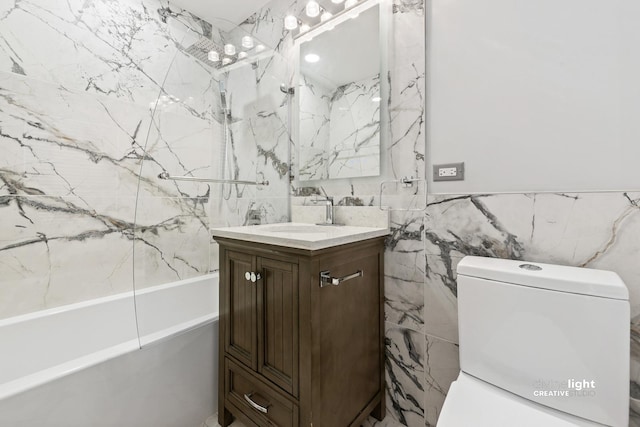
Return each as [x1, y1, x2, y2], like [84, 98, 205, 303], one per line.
[426, 193, 640, 316]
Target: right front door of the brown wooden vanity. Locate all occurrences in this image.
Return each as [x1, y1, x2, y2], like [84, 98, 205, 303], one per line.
[257, 258, 298, 396]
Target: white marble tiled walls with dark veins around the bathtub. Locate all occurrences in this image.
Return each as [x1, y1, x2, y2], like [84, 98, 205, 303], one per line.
[0, 0, 289, 318]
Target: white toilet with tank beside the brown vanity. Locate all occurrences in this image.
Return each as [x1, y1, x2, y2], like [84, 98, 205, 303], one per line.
[437, 256, 630, 427]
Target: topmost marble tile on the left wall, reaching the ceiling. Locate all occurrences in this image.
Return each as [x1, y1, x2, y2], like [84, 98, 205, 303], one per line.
[0, 0, 209, 115]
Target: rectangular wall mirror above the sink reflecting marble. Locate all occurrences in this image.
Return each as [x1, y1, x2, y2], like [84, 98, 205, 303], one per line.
[296, 1, 386, 181]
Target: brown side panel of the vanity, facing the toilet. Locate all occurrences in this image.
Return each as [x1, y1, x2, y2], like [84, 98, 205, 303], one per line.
[313, 253, 383, 426]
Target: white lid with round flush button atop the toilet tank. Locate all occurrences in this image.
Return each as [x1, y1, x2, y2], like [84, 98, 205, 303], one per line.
[457, 256, 629, 300]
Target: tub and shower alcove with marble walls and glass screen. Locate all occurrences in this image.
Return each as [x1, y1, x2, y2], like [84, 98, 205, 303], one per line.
[0, 0, 290, 427]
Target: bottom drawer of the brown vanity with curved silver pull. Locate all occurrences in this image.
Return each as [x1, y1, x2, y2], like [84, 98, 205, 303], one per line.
[225, 358, 298, 427]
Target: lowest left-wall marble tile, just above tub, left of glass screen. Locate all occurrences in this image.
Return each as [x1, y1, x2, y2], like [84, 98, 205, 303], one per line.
[0, 196, 133, 318]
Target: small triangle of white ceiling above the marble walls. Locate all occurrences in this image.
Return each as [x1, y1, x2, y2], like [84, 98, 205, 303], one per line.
[170, 0, 270, 31]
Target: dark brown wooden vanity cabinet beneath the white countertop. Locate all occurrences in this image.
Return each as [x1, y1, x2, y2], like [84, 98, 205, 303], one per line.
[215, 237, 385, 427]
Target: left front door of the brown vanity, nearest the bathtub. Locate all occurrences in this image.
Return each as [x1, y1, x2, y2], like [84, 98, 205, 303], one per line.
[225, 251, 258, 370]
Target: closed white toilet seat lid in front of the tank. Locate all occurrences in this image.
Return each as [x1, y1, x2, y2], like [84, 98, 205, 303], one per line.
[437, 371, 602, 427]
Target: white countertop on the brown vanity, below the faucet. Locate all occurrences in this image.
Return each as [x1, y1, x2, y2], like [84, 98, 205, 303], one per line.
[211, 222, 389, 250]
